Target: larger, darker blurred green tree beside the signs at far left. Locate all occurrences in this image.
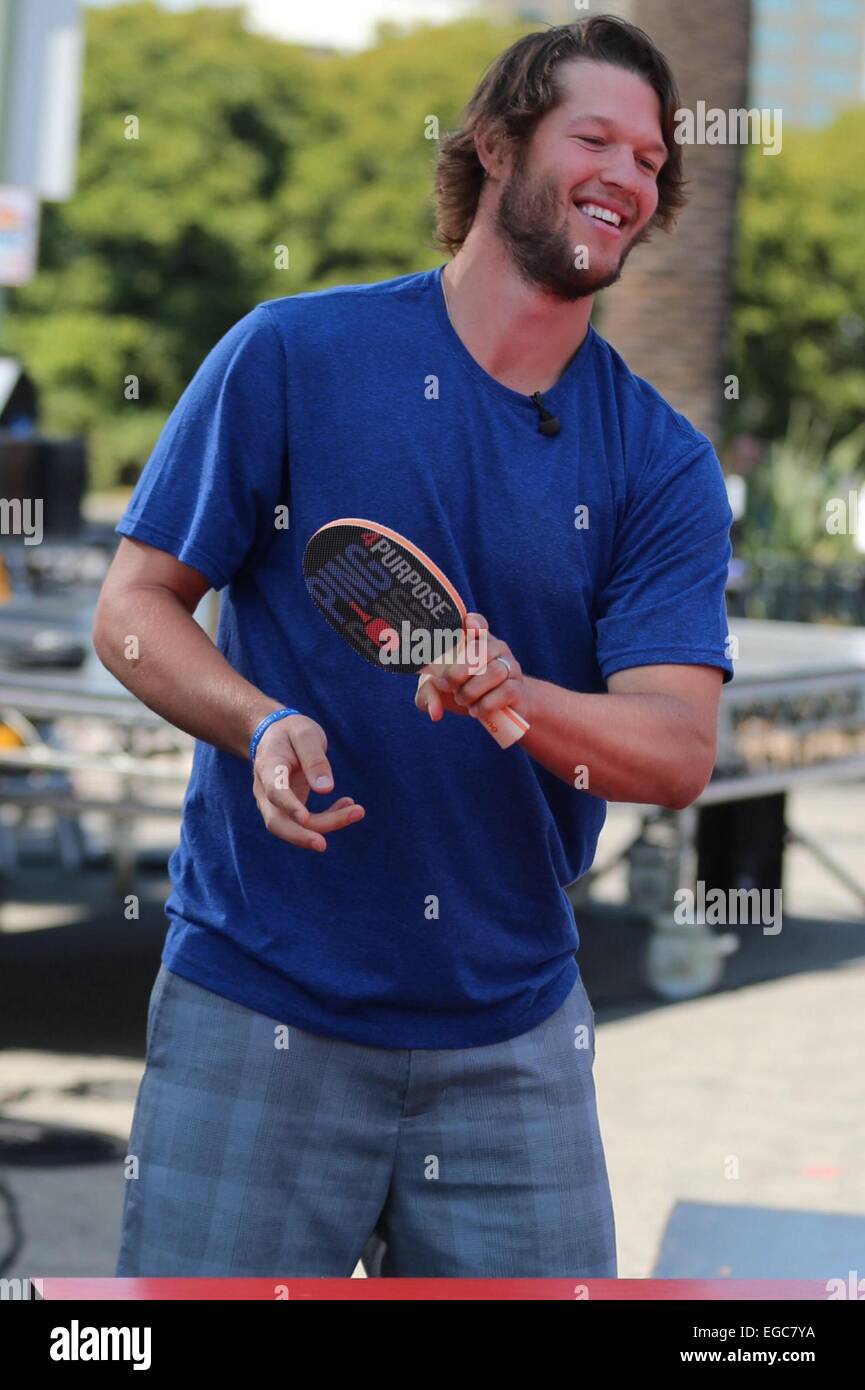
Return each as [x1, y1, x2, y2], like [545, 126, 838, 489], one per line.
[8, 3, 313, 482]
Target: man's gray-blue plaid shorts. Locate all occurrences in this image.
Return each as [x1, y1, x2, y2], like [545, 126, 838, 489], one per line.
[117, 965, 616, 1279]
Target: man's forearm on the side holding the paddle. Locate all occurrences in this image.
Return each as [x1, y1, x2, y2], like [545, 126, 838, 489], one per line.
[520, 676, 713, 809]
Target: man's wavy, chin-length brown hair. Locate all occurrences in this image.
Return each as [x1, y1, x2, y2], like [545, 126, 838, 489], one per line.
[434, 14, 686, 256]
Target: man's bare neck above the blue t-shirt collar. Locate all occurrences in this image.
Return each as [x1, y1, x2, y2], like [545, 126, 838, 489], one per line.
[442, 228, 592, 395]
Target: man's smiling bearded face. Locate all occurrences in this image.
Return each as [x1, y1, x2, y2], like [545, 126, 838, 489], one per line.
[494, 58, 668, 300]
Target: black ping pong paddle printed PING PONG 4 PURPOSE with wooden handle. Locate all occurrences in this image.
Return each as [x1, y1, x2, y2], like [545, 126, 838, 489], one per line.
[303, 517, 528, 748]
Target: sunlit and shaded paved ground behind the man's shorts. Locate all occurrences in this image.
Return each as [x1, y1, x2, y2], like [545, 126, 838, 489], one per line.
[0, 785, 865, 1277]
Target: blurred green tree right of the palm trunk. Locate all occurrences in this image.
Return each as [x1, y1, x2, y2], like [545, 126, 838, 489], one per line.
[733, 107, 865, 439]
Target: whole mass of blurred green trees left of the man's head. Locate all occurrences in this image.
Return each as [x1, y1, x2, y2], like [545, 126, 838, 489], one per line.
[8, 3, 524, 487]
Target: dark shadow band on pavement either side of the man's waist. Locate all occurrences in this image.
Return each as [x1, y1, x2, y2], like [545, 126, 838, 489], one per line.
[0, 866, 865, 1059]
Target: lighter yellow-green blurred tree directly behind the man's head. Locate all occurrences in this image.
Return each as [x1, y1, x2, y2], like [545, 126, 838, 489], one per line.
[264, 19, 522, 295]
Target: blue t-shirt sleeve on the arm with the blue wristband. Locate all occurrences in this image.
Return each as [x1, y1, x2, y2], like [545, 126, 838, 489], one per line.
[115, 304, 288, 589]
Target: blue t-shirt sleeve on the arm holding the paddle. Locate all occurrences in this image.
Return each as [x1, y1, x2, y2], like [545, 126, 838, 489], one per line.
[597, 439, 733, 684]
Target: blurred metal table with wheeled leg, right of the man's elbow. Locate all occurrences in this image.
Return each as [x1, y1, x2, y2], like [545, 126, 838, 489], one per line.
[569, 619, 865, 999]
